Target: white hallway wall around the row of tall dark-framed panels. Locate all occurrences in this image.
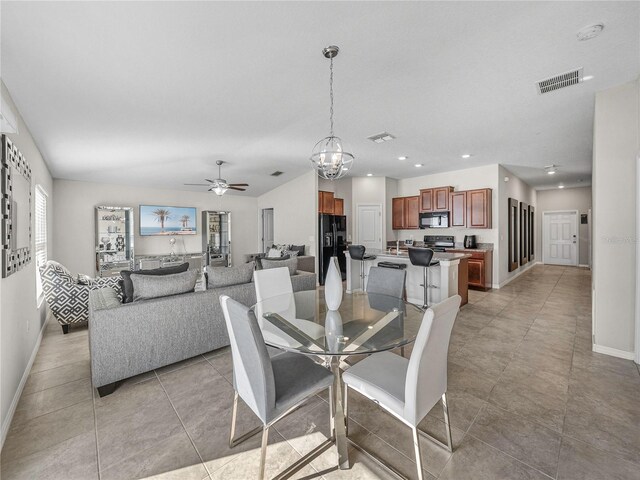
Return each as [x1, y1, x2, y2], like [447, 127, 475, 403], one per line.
[493, 165, 541, 286]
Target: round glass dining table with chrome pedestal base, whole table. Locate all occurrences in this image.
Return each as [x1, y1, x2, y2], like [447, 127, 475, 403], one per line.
[252, 290, 423, 478]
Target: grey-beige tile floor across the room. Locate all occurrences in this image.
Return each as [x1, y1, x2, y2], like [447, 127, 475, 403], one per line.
[1, 266, 640, 480]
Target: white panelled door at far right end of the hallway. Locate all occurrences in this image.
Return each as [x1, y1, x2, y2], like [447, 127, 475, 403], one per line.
[542, 211, 578, 265]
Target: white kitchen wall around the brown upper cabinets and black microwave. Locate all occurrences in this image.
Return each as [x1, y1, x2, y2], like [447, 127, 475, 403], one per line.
[389, 164, 500, 285]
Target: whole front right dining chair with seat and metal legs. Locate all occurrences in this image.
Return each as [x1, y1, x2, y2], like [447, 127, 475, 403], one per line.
[342, 295, 462, 480]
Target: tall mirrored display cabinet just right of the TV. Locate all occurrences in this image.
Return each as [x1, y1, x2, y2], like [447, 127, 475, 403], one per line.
[202, 211, 231, 267]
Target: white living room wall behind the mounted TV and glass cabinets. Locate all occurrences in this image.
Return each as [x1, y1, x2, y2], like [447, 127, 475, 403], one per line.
[52, 179, 259, 275]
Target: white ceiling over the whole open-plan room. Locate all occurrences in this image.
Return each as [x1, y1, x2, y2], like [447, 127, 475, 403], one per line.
[1, 1, 640, 196]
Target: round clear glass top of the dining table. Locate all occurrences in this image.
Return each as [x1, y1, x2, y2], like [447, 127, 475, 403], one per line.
[252, 290, 423, 355]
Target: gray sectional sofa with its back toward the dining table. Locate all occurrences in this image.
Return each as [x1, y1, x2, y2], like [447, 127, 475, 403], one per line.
[89, 270, 316, 396]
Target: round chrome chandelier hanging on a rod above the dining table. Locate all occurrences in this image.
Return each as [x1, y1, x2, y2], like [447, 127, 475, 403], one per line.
[311, 45, 354, 180]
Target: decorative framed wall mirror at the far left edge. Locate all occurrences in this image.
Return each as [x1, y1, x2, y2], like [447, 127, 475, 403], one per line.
[1, 135, 31, 278]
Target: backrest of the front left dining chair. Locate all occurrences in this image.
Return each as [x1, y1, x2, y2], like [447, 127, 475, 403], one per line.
[220, 295, 276, 423]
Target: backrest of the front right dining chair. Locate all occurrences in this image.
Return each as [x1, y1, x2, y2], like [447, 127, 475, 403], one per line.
[403, 295, 462, 425]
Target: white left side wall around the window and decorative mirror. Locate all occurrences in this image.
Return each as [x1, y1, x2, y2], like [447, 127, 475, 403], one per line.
[0, 82, 54, 443]
